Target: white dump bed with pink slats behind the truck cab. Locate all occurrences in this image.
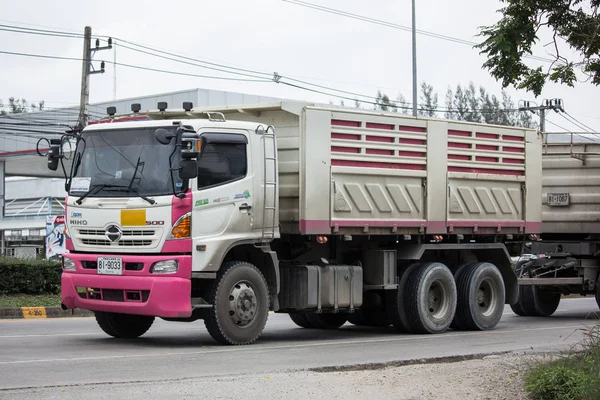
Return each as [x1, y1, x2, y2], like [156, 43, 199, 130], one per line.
[209, 102, 542, 234]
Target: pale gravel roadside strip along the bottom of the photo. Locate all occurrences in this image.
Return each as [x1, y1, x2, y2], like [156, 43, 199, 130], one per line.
[0, 354, 531, 400]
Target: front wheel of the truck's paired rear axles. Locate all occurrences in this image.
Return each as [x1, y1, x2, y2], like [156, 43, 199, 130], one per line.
[406, 262, 457, 333]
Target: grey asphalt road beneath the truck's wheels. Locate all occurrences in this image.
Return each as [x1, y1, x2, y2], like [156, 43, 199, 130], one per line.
[0, 298, 598, 398]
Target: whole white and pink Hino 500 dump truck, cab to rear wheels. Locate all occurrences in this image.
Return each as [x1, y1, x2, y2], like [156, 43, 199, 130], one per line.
[48, 101, 542, 344]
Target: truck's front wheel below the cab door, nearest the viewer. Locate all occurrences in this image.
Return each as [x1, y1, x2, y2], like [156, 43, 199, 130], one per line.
[204, 261, 269, 345]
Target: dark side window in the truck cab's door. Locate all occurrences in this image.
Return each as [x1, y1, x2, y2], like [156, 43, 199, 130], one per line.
[198, 143, 248, 189]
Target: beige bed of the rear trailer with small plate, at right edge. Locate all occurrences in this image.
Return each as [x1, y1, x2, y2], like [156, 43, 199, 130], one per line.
[542, 140, 600, 235]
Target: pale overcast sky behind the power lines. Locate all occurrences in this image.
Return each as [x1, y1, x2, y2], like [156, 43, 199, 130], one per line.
[0, 0, 600, 132]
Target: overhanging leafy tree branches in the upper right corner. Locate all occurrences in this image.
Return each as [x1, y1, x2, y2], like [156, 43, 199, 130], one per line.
[475, 0, 600, 96]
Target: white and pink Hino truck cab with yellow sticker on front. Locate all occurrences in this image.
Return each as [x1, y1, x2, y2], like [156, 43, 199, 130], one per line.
[49, 107, 279, 344]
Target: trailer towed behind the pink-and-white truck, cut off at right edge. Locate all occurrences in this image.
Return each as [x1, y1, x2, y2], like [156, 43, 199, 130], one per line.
[511, 133, 600, 316]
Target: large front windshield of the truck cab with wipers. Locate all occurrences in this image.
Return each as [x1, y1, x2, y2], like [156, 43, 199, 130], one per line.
[69, 126, 182, 197]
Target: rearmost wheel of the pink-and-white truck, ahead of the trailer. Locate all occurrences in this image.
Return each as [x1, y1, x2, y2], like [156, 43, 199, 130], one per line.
[453, 262, 506, 331]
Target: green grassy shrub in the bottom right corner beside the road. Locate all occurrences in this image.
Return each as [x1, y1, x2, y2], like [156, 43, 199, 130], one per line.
[525, 324, 600, 400]
